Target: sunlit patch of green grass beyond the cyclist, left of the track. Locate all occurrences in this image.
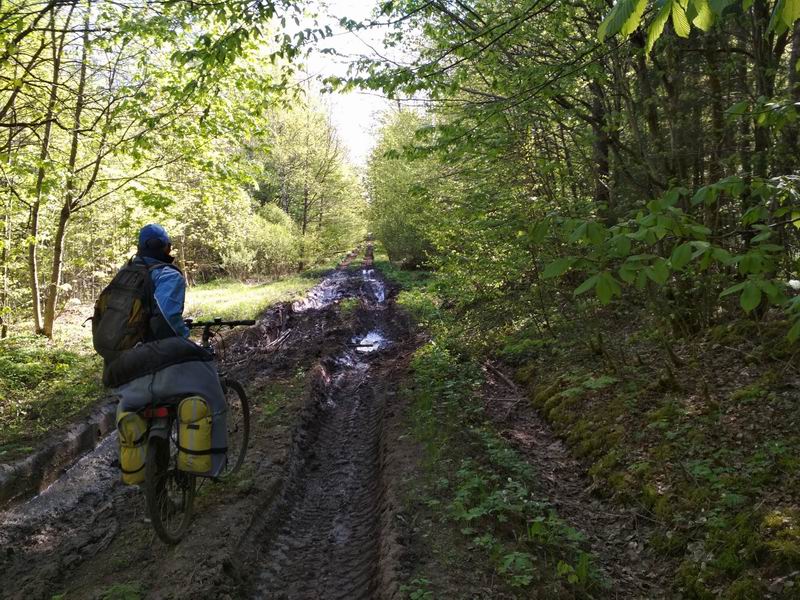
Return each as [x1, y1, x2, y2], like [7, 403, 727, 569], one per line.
[184, 270, 320, 319]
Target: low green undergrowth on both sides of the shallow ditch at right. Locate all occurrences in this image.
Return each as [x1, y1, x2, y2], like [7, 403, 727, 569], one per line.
[381, 246, 800, 600]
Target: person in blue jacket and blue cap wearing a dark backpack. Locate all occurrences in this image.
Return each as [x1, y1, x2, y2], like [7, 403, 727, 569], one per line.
[101, 224, 227, 476]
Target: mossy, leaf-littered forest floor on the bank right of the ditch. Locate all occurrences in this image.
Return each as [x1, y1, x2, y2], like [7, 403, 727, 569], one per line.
[518, 316, 800, 599]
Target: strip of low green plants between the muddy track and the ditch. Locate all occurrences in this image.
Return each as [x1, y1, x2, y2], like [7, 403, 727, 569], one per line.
[386, 248, 606, 598]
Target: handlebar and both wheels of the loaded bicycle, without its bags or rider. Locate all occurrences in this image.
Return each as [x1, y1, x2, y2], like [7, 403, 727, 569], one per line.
[142, 318, 255, 545]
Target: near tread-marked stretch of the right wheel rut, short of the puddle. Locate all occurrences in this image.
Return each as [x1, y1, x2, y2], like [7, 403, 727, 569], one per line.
[254, 354, 383, 599]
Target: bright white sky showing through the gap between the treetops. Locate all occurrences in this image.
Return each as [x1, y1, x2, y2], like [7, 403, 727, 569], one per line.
[307, 0, 391, 166]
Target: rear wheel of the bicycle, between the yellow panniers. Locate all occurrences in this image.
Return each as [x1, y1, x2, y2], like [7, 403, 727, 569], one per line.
[145, 437, 196, 545]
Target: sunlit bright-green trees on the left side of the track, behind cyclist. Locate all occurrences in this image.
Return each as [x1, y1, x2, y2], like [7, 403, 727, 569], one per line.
[0, 1, 364, 337]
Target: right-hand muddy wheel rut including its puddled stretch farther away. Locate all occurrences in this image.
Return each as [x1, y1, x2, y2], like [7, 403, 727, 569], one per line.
[241, 264, 392, 600]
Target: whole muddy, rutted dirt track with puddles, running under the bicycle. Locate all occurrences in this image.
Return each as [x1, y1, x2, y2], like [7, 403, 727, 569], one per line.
[0, 250, 409, 599]
